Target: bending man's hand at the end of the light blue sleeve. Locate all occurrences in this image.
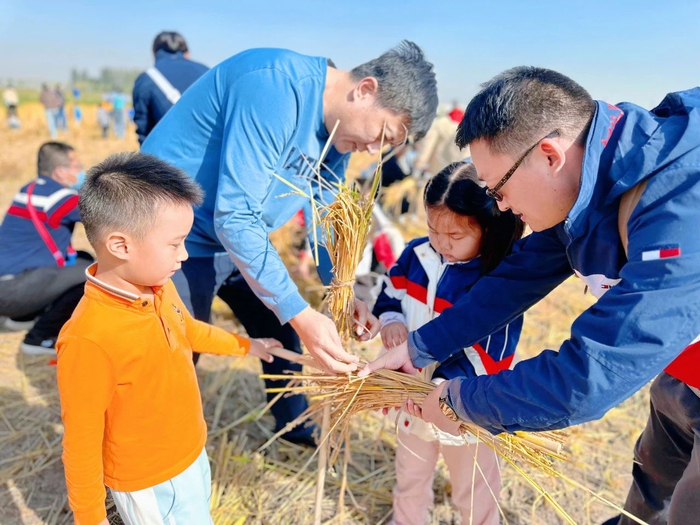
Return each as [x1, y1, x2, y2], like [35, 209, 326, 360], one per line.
[290, 306, 359, 374]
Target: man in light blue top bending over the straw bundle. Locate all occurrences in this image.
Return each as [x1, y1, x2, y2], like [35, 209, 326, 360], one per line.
[142, 42, 437, 442]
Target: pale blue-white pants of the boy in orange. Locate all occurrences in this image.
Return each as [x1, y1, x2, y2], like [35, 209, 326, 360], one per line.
[110, 450, 214, 525]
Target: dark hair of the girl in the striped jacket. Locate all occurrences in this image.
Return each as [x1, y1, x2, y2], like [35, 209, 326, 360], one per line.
[423, 162, 525, 273]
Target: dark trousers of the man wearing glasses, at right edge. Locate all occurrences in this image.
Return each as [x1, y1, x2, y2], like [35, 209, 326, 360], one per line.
[619, 373, 700, 525]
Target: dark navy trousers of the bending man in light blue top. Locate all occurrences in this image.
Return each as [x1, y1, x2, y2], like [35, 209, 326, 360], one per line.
[173, 256, 312, 438]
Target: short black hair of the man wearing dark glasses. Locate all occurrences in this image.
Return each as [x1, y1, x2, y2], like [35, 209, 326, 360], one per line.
[456, 66, 595, 155]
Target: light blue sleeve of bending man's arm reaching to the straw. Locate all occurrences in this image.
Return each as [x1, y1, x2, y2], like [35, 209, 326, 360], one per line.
[214, 69, 308, 324]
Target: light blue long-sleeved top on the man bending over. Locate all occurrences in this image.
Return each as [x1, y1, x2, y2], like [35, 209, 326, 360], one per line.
[141, 49, 349, 323]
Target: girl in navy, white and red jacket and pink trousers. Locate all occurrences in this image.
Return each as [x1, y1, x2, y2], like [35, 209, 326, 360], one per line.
[373, 162, 523, 525]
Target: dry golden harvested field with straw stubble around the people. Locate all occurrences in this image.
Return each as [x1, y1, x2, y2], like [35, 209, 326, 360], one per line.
[0, 104, 648, 525]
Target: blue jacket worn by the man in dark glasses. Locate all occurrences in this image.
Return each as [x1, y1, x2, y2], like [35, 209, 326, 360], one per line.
[409, 88, 700, 433]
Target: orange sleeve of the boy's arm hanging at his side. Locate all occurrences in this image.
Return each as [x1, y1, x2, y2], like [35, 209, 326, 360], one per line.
[57, 337, 116, 525]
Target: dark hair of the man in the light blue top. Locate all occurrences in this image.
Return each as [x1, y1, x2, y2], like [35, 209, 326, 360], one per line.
[350, 40, 438, 140]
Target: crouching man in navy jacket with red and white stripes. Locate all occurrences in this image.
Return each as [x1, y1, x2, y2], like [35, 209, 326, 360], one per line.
[0, 142, 92, 355]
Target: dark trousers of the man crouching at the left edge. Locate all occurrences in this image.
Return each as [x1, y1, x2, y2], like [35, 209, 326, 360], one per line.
[0, 253, 92, 343]
